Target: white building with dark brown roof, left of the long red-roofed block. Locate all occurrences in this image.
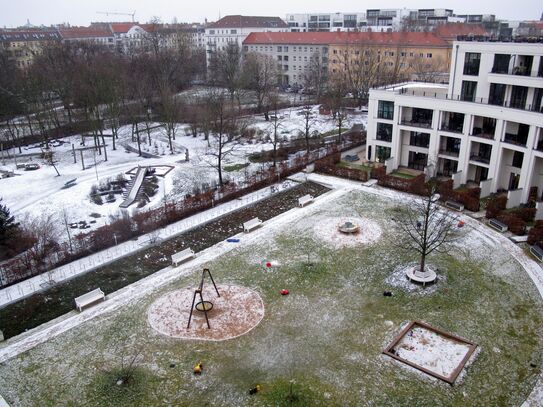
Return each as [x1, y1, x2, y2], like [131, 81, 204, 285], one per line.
[205, 15, 289, 66]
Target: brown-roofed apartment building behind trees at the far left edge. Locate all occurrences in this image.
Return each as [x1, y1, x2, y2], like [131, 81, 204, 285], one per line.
[0, 29, 61, 69]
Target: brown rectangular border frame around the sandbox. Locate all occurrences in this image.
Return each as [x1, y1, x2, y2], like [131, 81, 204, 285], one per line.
[382, 321, 477, 385]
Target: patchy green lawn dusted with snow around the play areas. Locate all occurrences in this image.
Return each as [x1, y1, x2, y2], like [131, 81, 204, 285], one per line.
[0, 186, 543, 406]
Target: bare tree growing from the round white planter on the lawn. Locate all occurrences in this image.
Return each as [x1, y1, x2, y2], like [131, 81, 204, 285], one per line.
[397, 183, 458, 275]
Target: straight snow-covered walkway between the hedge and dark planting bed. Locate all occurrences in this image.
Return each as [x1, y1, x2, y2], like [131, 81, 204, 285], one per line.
[0, 173, 305, 307]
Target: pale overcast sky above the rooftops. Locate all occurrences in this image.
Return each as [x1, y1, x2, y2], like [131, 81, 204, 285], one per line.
[0, 0, 543, 27]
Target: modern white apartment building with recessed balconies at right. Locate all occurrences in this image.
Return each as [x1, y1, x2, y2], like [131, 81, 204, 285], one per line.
[366, 42, 543, 203]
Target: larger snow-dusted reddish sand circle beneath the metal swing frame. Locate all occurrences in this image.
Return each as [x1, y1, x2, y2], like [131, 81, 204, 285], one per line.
[148, 283, 264, 341]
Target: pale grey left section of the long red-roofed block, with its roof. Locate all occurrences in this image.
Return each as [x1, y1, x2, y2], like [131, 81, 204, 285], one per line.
[243, 32, 332, 86]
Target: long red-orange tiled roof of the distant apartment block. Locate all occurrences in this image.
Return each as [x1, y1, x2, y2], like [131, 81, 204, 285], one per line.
[243, 32, 449, 47]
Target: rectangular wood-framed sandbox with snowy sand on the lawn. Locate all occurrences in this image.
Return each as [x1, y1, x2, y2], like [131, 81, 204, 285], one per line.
[383, 321, 477, 384]
